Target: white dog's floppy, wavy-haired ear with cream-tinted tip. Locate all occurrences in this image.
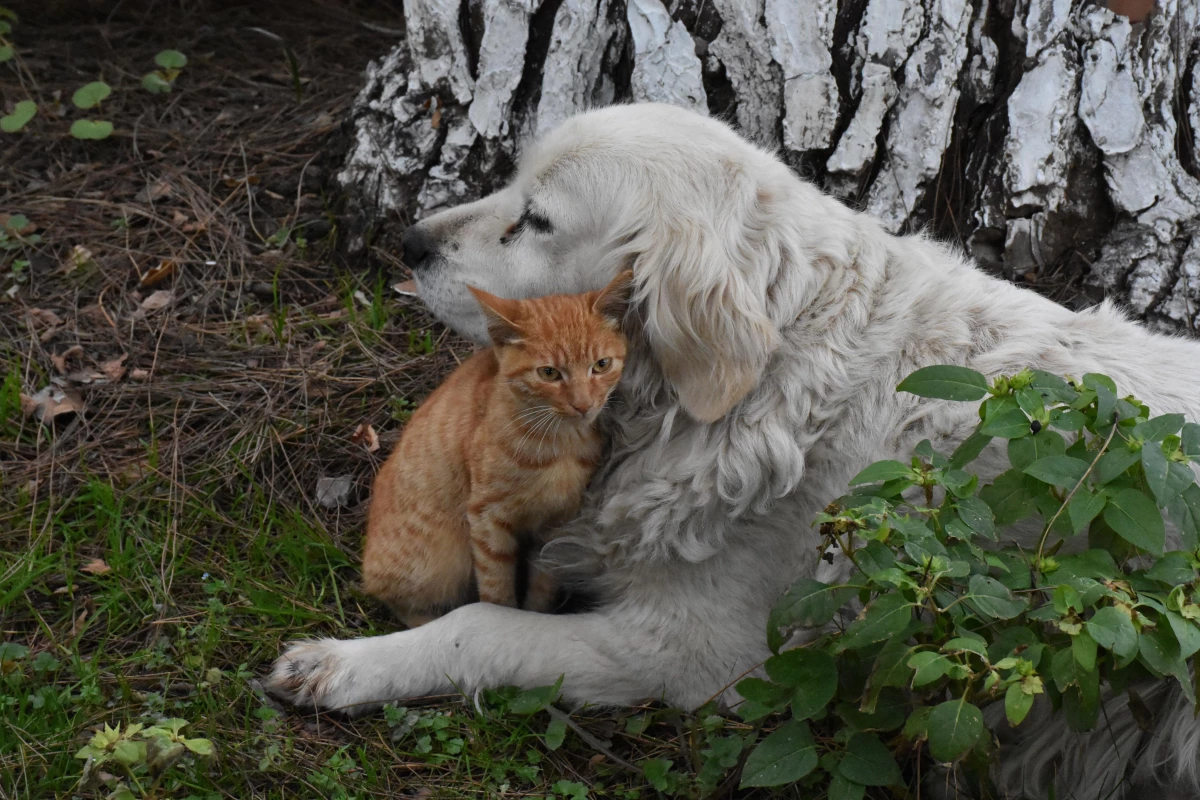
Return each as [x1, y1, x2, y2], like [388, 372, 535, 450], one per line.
[634, 219, 779, 422]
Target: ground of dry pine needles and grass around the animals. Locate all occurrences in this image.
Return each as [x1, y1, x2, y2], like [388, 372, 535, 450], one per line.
[0, 2, 732, 799]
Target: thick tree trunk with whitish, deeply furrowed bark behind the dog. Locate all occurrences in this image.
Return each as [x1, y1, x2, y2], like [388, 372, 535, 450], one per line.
[340, 0, 1200, 330]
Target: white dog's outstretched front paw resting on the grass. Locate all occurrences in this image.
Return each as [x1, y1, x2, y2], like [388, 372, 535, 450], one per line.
[265, 639, 371, 715]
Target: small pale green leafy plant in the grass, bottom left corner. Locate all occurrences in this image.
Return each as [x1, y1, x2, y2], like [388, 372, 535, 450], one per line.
[76, 720, 215, 800]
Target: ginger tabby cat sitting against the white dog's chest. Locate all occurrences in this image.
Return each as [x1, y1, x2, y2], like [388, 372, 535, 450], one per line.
[362, 271, 632, 627]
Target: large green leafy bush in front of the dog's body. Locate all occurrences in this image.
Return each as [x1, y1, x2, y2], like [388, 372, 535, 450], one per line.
[737, 366, 1200, 798]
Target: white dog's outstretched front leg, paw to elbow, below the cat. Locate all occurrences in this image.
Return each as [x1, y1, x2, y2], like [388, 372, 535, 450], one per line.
[268, 603, 664, 714]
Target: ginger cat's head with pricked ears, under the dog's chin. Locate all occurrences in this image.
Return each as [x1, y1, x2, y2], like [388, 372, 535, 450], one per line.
[468, 271, 634, 425]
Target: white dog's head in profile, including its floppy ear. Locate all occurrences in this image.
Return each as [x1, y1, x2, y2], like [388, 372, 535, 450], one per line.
[403, 104, 796, 422]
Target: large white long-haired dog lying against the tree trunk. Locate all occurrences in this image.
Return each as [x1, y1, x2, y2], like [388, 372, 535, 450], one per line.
[271, 104, 1200, 798]
